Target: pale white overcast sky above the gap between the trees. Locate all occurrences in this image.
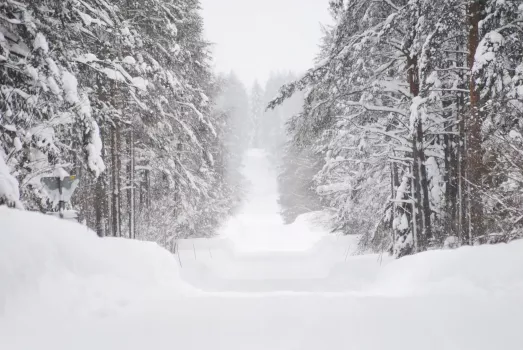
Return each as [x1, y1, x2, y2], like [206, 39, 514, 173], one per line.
[200, 0, 330, 85]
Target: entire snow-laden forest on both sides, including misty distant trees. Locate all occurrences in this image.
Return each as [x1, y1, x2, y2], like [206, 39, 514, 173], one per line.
[0, 0, 523, 257]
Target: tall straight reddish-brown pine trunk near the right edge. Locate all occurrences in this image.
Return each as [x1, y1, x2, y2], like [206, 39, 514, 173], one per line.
[465, 0, 485, 244]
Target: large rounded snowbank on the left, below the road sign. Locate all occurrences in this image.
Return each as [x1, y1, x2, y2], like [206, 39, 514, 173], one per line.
[0, 207, 188, 315]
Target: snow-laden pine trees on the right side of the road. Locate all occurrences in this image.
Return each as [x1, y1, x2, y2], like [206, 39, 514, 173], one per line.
[270, 0, 523, 256]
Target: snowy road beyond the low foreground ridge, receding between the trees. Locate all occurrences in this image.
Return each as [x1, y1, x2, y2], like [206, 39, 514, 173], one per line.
[177, 149, 364, 292]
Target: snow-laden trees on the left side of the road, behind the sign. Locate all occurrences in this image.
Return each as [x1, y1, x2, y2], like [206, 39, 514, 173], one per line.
[0, 0, 250, 246]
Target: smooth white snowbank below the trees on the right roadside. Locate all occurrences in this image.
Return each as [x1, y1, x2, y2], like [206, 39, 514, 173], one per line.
[369, 240, 523, 296]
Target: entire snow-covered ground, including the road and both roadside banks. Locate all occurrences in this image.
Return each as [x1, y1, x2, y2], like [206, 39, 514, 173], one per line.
[0, 150, 523, 350]
